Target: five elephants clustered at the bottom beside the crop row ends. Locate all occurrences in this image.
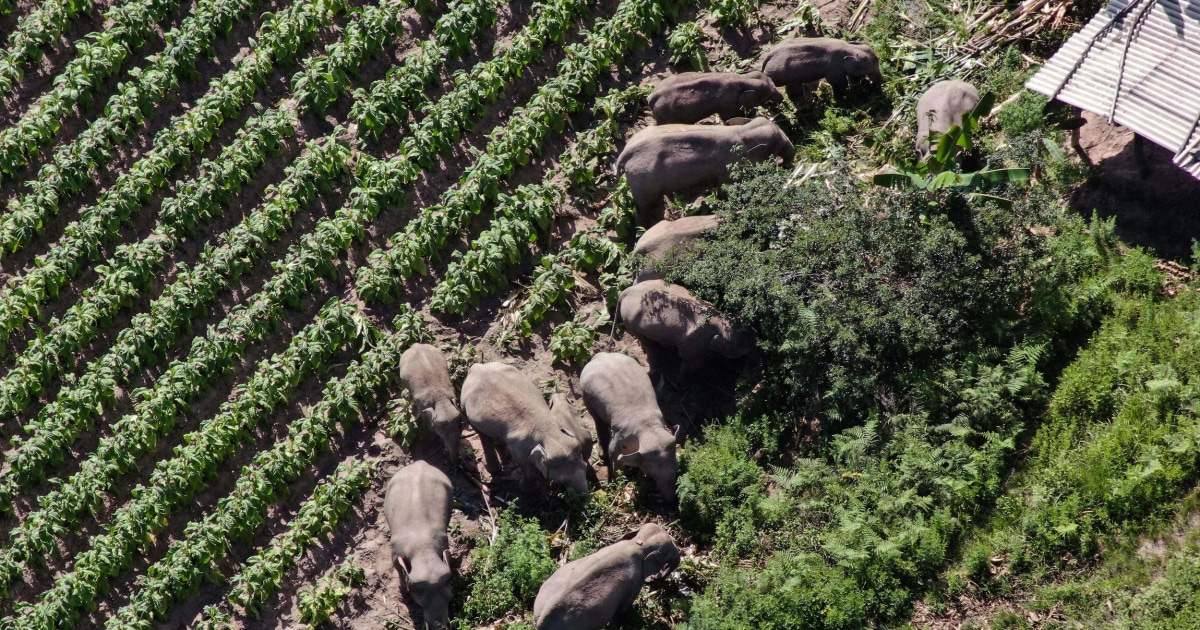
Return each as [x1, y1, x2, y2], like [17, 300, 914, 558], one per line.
[384, 343, 679, 629]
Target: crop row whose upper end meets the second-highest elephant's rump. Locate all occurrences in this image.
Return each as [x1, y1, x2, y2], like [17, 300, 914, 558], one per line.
[430, 86, 646, 314]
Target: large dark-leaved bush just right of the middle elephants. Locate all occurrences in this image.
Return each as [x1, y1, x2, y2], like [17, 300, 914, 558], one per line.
[662, 167, 1128, 450]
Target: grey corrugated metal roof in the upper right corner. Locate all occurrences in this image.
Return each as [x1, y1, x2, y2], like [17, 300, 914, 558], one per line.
[1025, 0, 1200, 179]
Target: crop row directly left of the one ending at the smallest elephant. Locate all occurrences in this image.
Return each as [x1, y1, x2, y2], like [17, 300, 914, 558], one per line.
[5, 300, 370, 628]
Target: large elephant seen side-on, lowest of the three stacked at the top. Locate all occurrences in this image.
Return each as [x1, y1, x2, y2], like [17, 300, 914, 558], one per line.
[613, 118, 796, 221]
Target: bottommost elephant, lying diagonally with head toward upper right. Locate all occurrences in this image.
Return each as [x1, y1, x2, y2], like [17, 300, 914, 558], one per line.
[533, 523, 679, 630]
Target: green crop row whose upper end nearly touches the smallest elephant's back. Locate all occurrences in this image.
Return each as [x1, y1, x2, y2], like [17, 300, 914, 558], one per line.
[97, 312, 428, 630]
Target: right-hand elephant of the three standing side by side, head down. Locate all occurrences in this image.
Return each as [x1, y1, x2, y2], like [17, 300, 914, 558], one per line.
[580, 353, 679, 503]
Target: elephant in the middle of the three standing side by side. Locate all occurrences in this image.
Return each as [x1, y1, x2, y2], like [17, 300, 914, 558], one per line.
[461, 362, 592, 494]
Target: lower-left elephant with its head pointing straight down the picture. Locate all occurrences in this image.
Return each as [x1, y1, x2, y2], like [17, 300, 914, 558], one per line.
[383, 462, 454, 629]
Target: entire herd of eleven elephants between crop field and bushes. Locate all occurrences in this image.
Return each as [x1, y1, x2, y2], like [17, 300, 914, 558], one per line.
[374, 38, 979, 630]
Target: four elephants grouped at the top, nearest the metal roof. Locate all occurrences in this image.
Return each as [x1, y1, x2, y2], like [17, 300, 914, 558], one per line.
[613, 37, 979, 218]
